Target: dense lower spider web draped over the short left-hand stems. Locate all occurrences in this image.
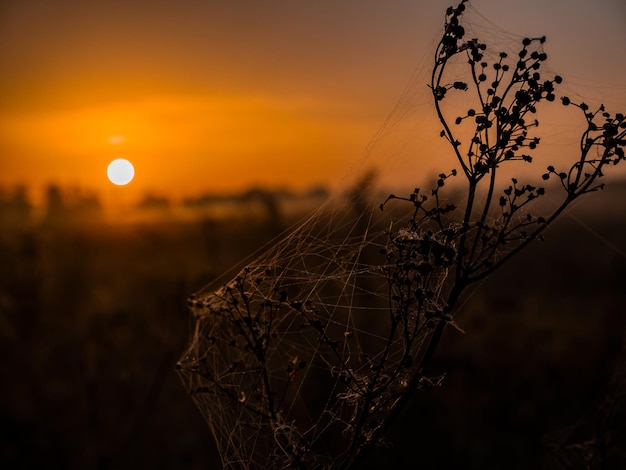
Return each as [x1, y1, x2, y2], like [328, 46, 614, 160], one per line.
[179, 191, 445, 468]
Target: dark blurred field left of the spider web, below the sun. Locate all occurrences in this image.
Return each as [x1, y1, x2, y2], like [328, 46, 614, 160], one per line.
[0, 186, 323, 469]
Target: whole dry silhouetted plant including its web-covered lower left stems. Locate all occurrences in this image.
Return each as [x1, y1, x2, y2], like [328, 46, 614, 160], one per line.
[178, 0, 626, 469]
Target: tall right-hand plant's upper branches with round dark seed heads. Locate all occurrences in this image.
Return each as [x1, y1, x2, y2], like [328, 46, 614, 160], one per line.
[370, 0, 626, 466]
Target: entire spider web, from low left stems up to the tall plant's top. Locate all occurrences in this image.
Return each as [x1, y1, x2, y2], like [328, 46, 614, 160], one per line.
[178, 2, 620, 469]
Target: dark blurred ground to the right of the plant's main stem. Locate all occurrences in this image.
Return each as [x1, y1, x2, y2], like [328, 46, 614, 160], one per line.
[364, 184, 626, 469]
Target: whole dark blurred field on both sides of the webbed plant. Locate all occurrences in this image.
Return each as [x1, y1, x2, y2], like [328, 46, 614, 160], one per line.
[0, 179, 626, 469]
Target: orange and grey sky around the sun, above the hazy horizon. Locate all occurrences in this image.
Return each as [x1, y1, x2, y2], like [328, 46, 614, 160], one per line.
[0, 0, 626, 206]
